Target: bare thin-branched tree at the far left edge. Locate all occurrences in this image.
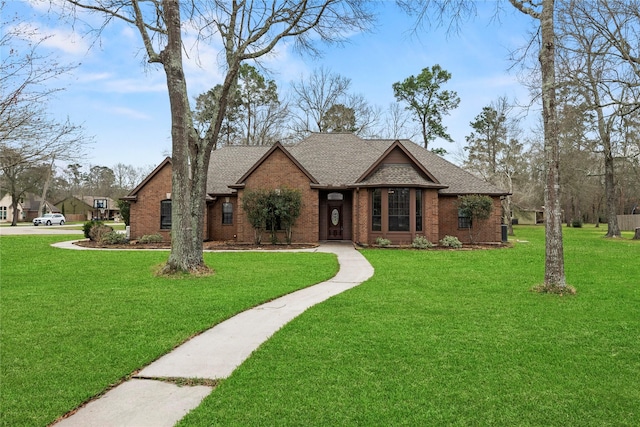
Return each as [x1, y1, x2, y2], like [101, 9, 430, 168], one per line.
[0, 2, 90, 225]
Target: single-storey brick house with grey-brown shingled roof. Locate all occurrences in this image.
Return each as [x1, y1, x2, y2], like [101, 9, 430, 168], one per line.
[124, 133, 508, 244]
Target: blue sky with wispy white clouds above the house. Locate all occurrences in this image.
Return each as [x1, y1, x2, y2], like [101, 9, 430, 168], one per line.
[5, 0, 537, 172]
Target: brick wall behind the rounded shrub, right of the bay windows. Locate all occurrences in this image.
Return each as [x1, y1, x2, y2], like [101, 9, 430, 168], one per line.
[438, 196, 502, 243]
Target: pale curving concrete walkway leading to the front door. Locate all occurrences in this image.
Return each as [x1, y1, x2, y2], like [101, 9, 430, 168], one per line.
[56, 243, 373, 427]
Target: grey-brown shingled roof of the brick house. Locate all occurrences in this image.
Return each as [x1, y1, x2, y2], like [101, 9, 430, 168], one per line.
[207, 133, 507, 195]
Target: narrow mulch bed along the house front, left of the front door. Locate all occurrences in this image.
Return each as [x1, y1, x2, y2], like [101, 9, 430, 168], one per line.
[74, 240, 318, 251]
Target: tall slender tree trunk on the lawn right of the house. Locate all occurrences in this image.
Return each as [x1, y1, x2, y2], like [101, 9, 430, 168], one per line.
[540, 0, 566, 287]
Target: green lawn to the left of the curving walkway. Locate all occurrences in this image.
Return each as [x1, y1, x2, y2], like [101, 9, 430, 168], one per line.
[0, 236, 337, 426]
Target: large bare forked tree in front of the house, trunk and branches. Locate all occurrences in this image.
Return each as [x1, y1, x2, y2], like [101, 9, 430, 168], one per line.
[58, 0, 372, 273]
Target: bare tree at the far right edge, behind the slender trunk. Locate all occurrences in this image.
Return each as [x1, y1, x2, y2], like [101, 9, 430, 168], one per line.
[557, 0, 640, 237]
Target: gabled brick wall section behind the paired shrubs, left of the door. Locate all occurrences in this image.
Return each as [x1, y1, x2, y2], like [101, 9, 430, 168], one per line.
[237, 149, 320, 243]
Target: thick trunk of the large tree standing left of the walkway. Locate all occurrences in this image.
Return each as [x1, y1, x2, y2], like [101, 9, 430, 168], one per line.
[161, 0, 209, 273]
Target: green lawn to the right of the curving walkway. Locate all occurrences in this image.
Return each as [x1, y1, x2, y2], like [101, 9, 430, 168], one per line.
[180, 226, 640, 427]
